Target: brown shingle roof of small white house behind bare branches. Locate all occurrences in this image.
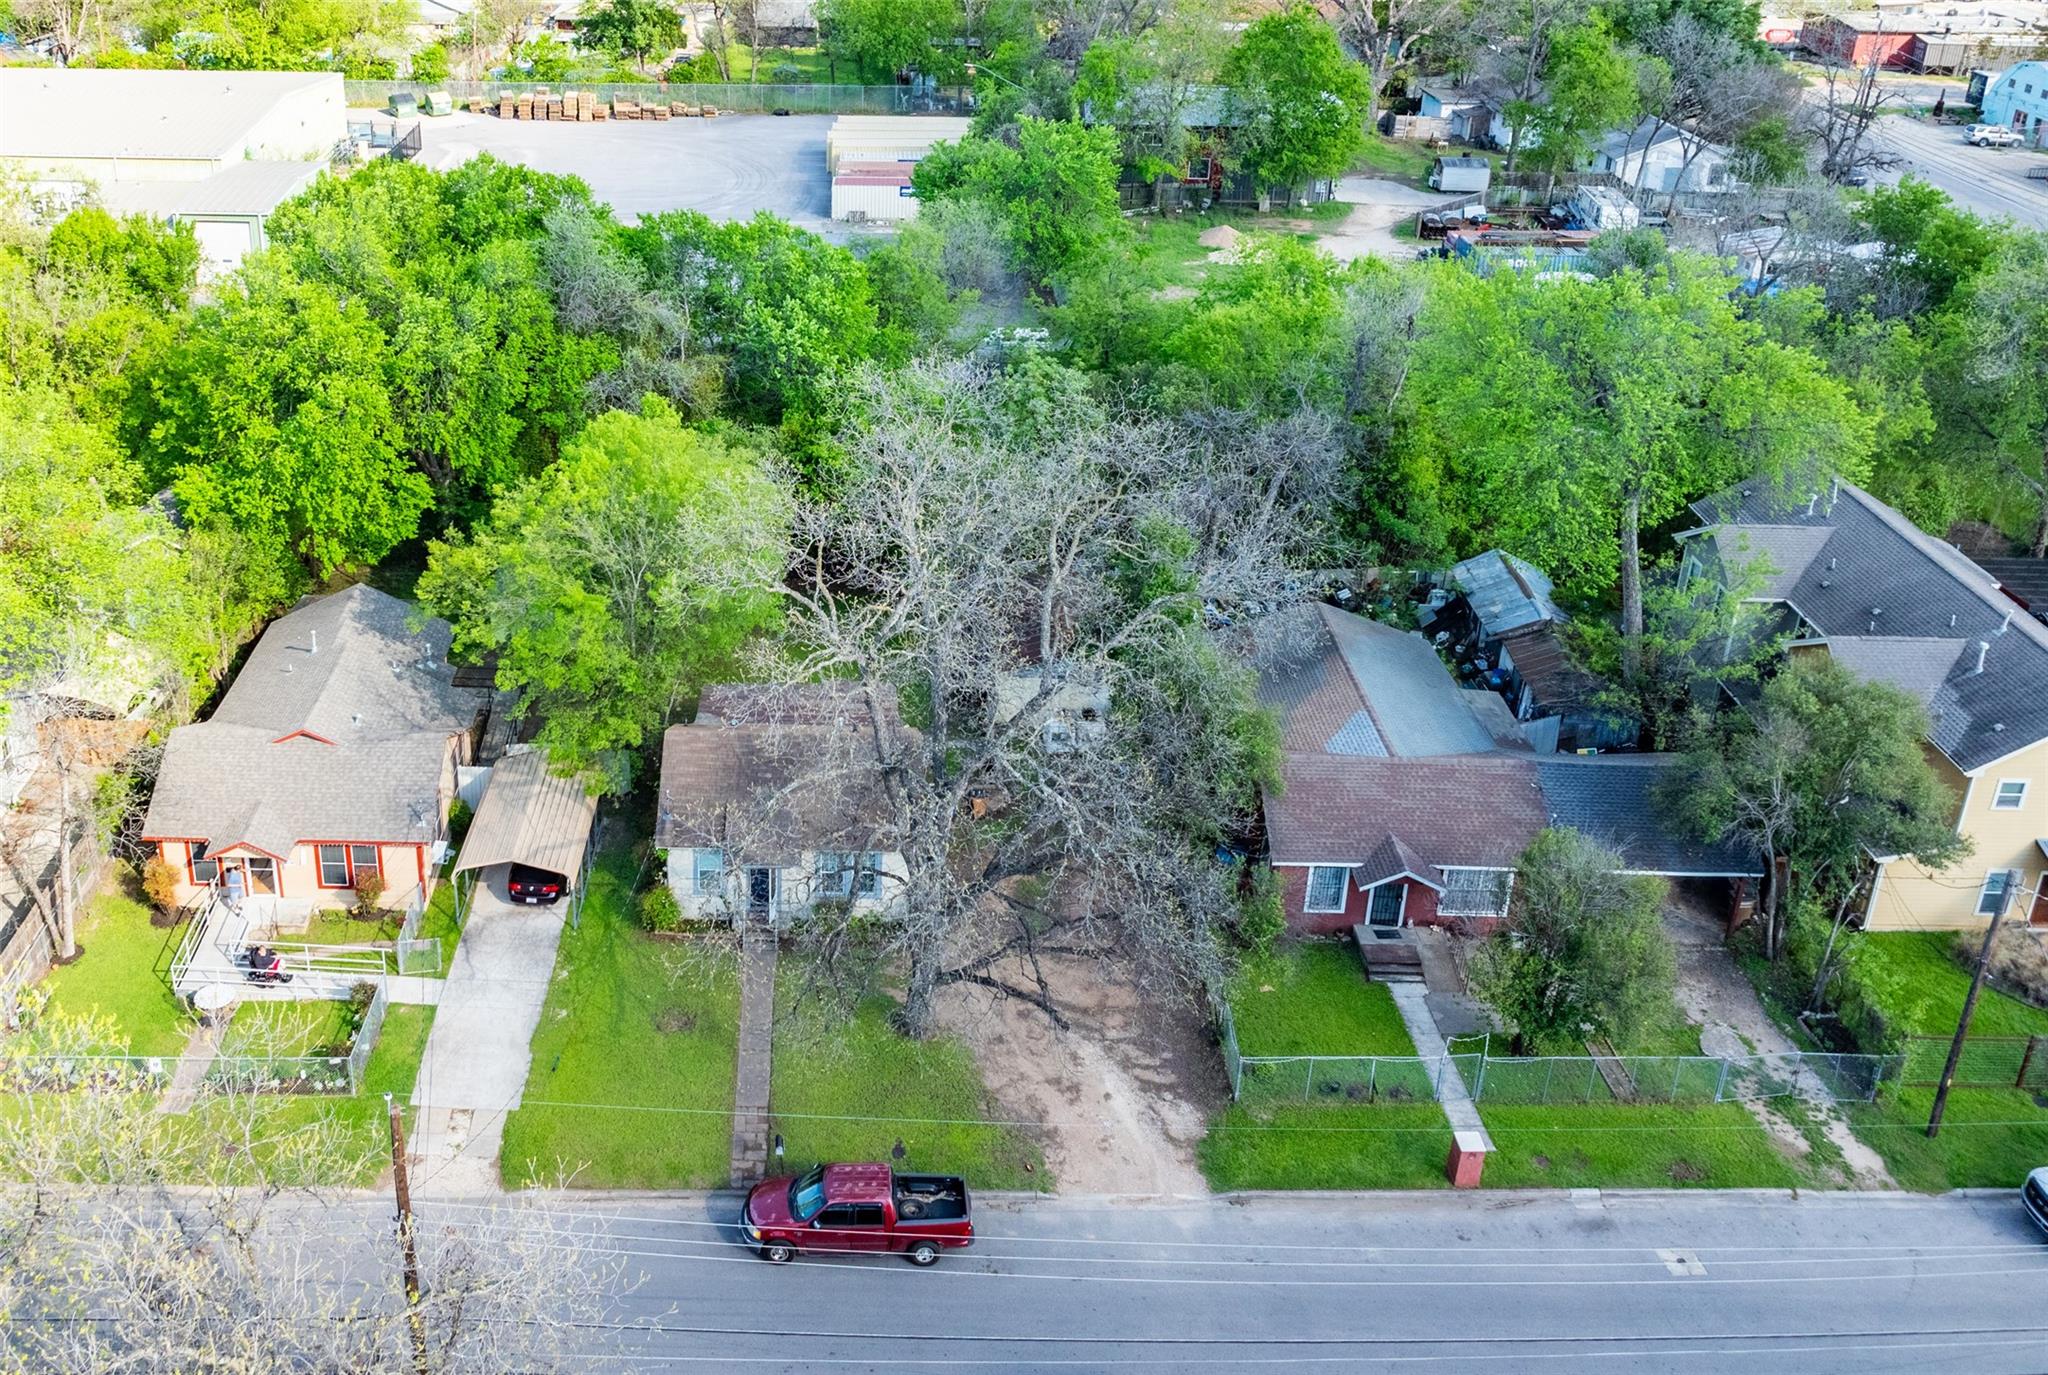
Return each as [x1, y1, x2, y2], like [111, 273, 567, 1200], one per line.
[655, 684, 911, 863]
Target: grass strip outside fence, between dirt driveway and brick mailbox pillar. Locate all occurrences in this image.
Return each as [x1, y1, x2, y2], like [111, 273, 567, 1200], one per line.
[1196, 1102, 1450, 1193]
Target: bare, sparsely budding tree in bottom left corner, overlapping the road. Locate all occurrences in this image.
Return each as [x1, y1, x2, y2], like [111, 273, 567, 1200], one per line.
[0, 1016, 631, 1375]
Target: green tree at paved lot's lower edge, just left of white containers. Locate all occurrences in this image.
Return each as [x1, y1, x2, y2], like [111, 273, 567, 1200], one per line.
[621, 211, 877, 422]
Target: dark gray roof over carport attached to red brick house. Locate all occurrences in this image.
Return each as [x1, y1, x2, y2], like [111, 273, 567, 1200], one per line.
[1536, 754, 1763, 875]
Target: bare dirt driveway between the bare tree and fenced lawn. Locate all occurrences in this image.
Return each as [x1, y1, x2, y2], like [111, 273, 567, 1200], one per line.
[938, 959, 1225, 1197]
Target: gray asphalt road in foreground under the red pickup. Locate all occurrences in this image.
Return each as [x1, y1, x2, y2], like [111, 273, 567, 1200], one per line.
[403, 1191, 2048, 1375]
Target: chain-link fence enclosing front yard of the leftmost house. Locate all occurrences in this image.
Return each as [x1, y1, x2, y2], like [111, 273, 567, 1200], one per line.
[0, 984, 389, 1096]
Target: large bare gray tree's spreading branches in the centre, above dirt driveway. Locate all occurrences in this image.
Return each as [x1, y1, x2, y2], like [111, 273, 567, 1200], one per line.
[700, 363, 1337, 1035]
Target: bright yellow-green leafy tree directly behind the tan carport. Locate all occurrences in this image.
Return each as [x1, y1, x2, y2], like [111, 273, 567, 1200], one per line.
[420, 398, 788, 791]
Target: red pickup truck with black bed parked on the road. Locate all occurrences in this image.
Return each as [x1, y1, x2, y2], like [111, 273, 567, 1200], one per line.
[739, 1164, 975, 1264]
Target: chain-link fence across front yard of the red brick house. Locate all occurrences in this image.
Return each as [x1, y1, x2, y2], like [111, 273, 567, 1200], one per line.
[1223, 1025, 1903, 1105]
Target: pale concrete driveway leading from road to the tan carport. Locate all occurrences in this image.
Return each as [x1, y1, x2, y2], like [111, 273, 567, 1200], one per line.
[410, 871, 567, 1195]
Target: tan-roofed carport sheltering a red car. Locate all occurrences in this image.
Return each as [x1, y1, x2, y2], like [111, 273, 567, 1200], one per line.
[453, 748, 598, 926]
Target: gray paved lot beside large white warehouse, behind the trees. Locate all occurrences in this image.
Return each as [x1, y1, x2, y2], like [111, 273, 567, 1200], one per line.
[420, 113, 846, 238]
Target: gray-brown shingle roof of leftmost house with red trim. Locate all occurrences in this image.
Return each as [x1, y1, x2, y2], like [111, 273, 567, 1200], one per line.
[143, 586, 485, 857]
